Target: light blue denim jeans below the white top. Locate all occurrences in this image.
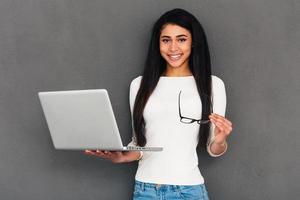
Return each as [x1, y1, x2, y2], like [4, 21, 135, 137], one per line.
[133, 180, 209, 200]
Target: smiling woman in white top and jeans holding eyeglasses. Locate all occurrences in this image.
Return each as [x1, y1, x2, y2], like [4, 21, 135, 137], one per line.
[86, 9, 232, 200]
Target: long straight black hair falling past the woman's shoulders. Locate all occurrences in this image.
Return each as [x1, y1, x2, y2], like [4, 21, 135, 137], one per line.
[133, 8, 212, 151]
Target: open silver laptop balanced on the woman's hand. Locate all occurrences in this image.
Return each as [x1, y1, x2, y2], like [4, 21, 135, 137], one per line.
[38, 89, 163, 151]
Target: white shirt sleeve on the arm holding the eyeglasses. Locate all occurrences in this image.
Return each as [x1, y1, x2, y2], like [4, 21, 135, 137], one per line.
[206, 75, 227, 157]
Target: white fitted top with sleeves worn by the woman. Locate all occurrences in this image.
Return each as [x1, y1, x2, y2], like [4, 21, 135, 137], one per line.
[128, 75, 226, 185]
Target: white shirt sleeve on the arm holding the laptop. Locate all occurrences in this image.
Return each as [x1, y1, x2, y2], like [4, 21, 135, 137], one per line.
[127, 76, 142, 146]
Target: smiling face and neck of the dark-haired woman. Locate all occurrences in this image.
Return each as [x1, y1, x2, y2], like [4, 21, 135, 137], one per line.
[159, 24, 192, 72]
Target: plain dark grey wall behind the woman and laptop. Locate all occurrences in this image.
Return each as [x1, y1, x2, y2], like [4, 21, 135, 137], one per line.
[0, 0, 300, 200]
